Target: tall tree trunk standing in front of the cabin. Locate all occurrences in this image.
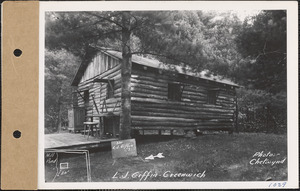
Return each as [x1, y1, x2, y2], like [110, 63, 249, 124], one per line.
[119, 12, 132, 139]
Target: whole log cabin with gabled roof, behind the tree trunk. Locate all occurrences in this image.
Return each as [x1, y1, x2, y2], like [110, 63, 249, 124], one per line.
[69, 50, 238, 137]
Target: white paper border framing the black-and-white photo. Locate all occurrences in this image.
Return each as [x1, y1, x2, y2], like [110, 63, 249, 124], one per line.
[38, 1, 299, 189]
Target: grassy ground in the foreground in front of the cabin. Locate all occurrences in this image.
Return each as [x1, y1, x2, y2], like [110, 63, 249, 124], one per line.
[46, 133, 287, 182]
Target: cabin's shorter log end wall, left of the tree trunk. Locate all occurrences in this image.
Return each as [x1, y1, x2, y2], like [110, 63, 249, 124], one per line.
[77, 59, 121, 115]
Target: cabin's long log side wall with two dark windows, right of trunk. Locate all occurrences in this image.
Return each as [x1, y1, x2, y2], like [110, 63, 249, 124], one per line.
[131, 64, 235, 130]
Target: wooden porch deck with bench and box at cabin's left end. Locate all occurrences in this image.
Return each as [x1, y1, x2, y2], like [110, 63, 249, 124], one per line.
[45, 109, 120, 149]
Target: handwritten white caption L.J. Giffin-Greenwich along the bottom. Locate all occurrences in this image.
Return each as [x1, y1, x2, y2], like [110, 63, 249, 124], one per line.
[112, 170, 206, 181]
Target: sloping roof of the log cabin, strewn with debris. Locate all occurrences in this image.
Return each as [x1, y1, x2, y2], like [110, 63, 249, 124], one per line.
[72, 50, 238, 87]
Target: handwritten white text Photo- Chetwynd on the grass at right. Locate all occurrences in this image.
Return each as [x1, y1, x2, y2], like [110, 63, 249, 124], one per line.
[249, 151, 286, 166]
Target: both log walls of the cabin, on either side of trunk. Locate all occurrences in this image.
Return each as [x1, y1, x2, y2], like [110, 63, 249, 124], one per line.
[74, 52, 235, 130]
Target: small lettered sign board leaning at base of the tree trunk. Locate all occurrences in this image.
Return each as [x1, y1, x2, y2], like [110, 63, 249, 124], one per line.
[111, 139, 137, 158]
